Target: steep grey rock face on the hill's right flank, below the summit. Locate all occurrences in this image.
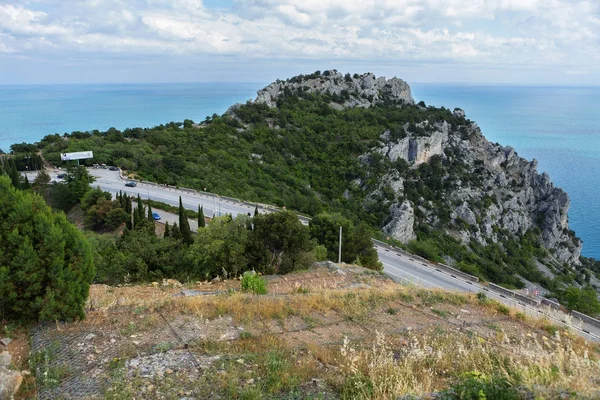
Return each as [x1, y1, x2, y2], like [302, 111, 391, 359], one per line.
[376, 110, 582, 265]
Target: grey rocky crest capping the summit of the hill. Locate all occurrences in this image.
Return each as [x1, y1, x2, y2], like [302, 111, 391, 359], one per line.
[254, 70, 414, 109]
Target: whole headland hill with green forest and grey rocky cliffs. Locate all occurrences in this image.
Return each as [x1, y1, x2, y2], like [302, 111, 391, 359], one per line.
[12, 71, 600, 298]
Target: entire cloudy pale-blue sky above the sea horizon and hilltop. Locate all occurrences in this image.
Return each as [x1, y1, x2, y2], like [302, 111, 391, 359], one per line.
[0, 0, 600, 85]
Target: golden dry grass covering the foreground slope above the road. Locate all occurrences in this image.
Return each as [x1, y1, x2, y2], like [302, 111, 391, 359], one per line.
[36, 271, 600, 399]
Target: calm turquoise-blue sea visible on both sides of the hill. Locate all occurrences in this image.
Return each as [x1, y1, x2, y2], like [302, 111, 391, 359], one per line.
[0, 83, 600, 259]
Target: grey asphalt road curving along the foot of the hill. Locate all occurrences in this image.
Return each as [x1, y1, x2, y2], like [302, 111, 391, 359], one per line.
[29, 169, 600, 341]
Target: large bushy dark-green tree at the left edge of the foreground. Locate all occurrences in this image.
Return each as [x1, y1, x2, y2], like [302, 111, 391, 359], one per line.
[0, 177, 94, 321]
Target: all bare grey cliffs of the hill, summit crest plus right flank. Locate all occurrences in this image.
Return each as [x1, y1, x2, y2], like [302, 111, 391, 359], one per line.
[244, 70, 582, 266]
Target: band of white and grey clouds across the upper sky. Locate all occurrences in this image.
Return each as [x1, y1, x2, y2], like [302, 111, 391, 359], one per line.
[0, 0, 600, 82]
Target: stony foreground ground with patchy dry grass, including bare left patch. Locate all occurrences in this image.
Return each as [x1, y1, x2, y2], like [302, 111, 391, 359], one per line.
[8, 263, 600, 399]
